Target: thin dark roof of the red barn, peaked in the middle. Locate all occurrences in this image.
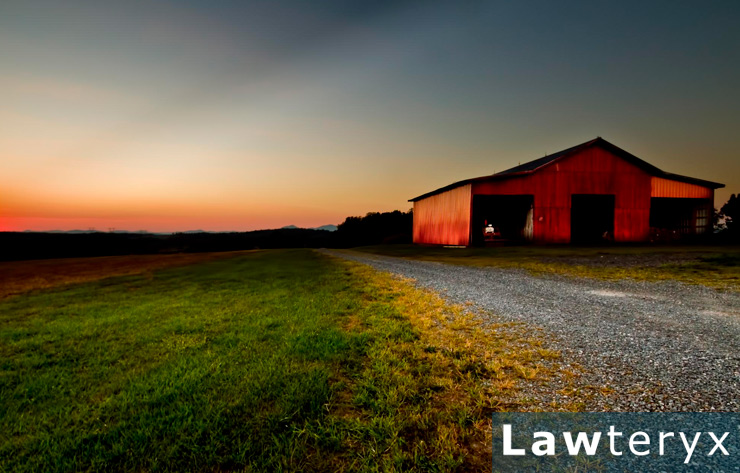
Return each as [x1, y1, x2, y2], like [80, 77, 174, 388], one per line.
[409, 136, 725, 202]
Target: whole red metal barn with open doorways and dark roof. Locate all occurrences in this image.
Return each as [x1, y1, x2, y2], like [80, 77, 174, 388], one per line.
[410, 138, 724, 246]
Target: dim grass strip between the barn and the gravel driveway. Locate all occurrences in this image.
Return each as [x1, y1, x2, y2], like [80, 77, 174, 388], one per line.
[357, 245, 740, 291]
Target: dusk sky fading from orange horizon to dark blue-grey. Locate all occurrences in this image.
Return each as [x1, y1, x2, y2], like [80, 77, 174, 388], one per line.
[0, 0, 740, 231]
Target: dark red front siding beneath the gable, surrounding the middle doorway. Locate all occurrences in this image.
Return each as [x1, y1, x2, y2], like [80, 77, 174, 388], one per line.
[473, 147, 651, 243]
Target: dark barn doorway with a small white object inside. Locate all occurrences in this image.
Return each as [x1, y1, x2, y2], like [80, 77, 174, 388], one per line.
[472, 195, 534, 245]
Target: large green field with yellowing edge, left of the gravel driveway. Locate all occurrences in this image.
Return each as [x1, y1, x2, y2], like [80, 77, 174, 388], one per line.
[0, 250, 582, 472]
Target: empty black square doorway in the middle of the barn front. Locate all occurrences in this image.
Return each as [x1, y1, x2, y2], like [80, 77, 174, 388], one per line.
[570, 194, 614, 244]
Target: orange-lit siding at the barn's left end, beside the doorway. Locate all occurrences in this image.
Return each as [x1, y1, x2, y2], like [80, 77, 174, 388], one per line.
[414, 184, 472, 246]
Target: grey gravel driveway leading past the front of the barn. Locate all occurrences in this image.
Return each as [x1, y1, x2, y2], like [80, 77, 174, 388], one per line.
[327, 251, 740, 411]
